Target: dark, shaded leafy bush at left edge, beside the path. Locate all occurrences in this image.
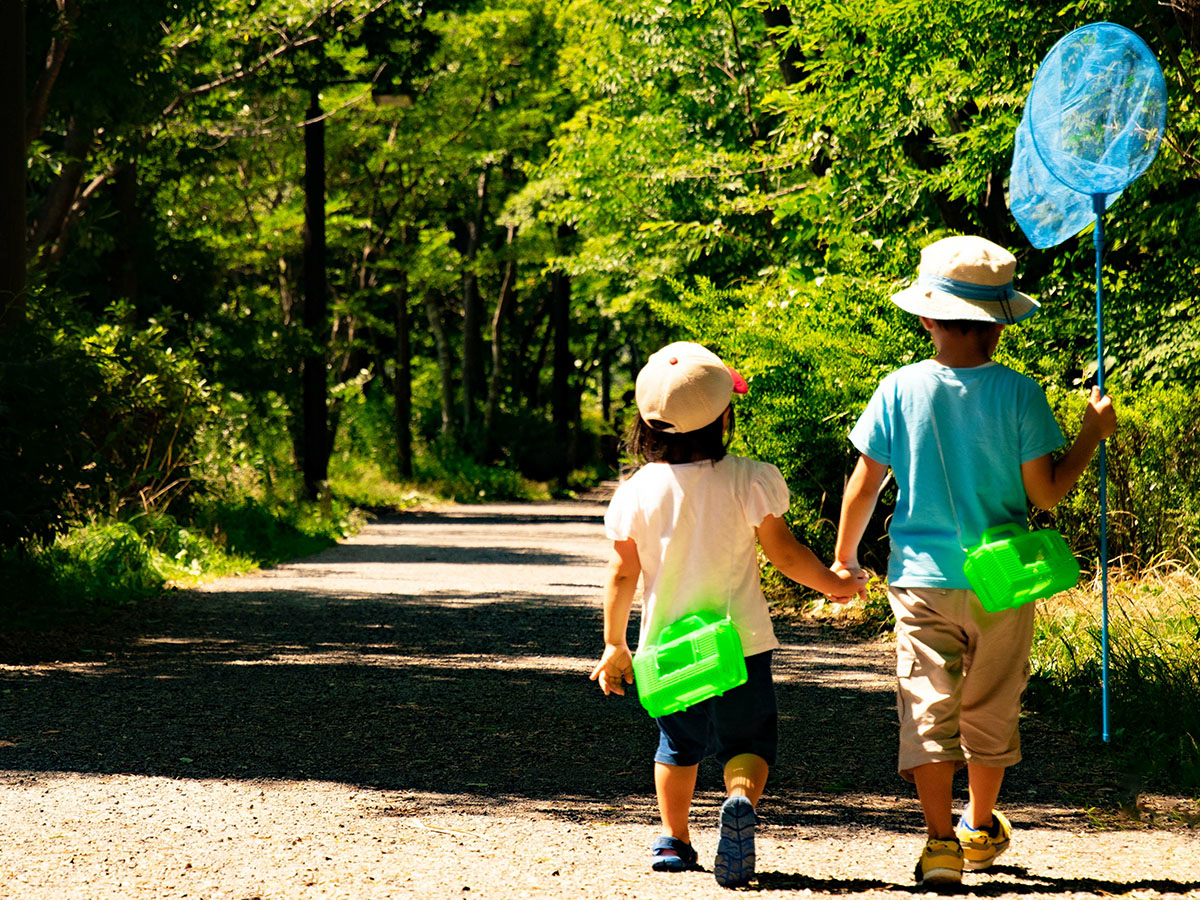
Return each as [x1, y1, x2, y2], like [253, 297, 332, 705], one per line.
[0, 292, 215, 544]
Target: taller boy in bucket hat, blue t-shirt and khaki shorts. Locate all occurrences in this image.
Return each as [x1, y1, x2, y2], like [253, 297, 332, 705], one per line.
[834, 236, 1116, 884]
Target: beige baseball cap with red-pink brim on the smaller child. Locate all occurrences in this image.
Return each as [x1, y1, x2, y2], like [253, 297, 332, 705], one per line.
[636, 341, 749, 434]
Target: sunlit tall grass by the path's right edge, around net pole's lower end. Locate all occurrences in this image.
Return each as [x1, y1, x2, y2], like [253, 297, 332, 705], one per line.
[1027, 563, 1200, 791]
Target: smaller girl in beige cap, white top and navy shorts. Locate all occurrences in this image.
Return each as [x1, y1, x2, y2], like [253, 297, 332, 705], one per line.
[592, 342, 866, 887]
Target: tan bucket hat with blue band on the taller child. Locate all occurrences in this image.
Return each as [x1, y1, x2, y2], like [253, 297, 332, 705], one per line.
[892, 235, 1042, 325]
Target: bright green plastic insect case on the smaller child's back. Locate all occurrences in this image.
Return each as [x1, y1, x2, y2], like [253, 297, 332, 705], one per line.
[634, 612, 746, 718]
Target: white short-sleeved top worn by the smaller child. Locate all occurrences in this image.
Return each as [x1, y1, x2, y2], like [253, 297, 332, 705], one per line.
[605, 456, 791, 656]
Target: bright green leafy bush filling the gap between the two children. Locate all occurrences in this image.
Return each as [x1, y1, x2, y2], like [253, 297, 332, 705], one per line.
[654, 275, 925, 569]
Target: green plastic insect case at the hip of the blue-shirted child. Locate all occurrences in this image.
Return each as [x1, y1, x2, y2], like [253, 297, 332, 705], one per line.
[962, 522, 1079, 612]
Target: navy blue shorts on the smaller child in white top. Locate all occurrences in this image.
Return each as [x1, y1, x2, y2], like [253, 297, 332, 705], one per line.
[654, 650, 779, 766]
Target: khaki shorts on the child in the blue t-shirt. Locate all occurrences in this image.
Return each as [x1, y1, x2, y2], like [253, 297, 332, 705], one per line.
[888, 587, 1034, 781]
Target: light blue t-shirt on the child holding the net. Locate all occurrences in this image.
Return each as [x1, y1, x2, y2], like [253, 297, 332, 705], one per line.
[850, 360, 1064, 588]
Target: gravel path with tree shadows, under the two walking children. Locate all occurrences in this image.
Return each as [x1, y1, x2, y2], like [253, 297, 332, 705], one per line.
[0, 503, 1200, 900]
